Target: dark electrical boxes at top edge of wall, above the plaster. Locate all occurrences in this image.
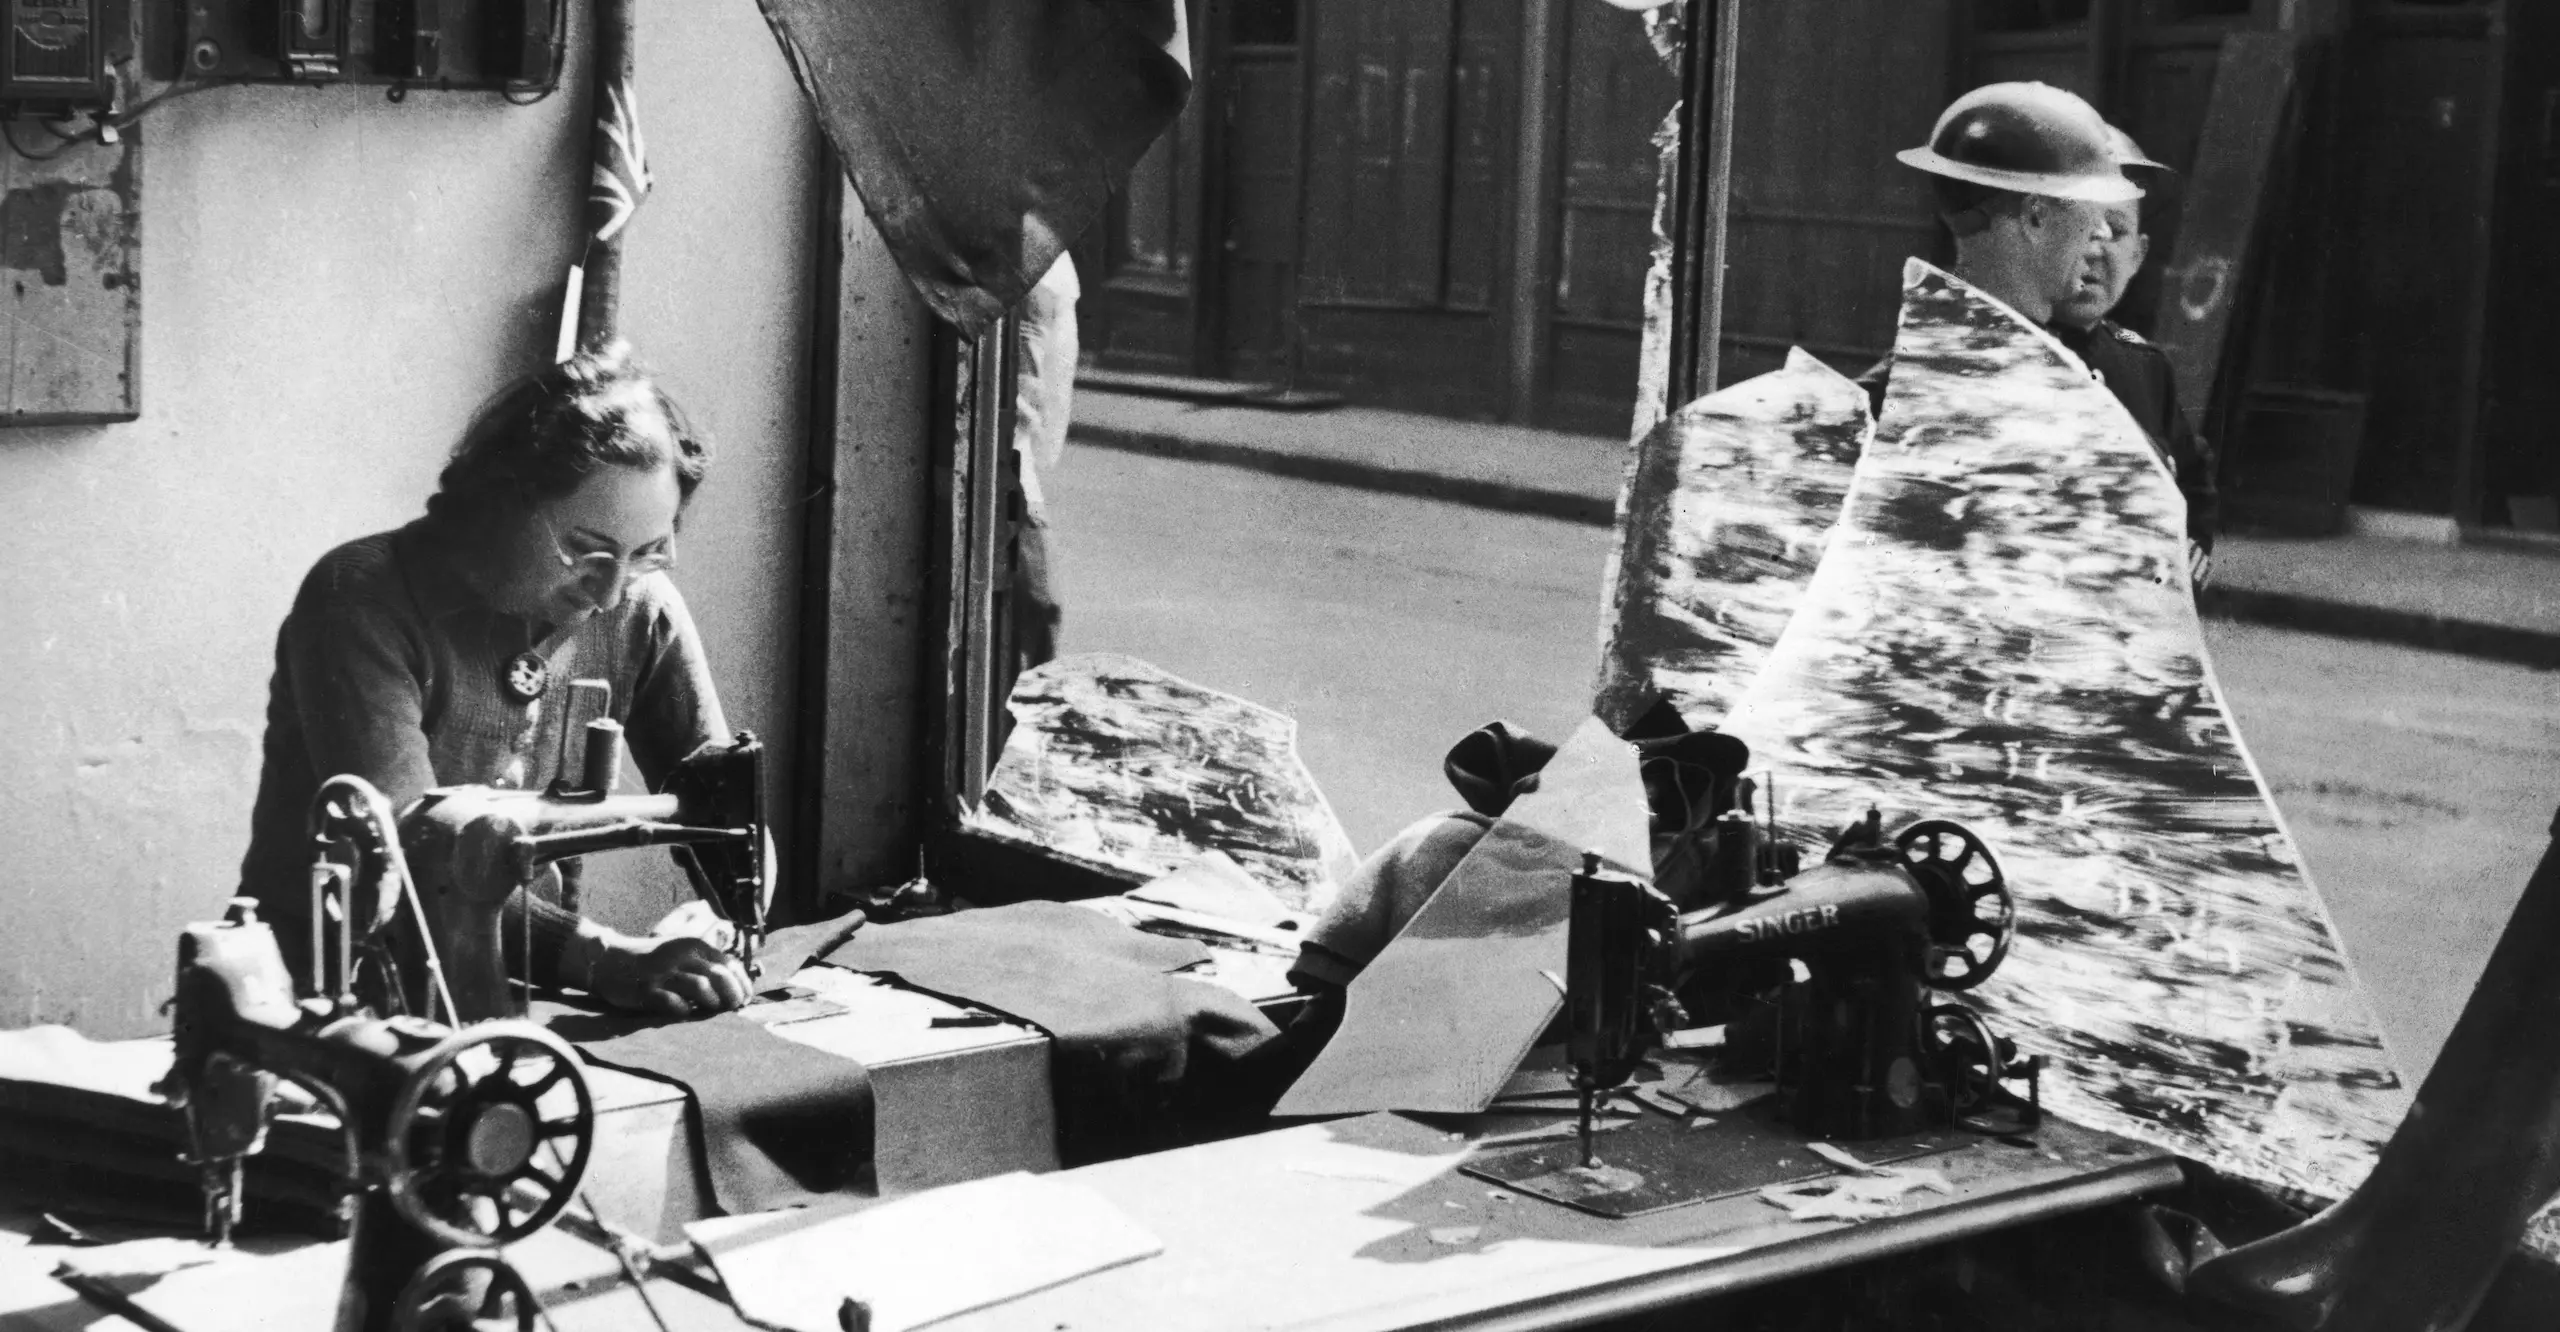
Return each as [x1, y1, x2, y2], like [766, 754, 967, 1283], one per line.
[149, 0, 568, 92]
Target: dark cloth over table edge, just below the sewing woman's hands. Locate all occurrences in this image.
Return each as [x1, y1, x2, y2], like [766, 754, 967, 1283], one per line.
[532, 999, 873, 1214]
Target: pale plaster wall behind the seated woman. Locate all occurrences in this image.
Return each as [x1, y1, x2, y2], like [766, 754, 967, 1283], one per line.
[0, 0, 839, 1037]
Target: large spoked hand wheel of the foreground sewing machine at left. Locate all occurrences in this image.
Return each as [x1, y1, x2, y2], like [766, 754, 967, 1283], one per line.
[384, 1022, 596, 1247]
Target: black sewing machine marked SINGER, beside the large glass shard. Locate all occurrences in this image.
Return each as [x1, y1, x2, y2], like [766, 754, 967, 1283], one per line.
[1564, 797, 2040, 1166]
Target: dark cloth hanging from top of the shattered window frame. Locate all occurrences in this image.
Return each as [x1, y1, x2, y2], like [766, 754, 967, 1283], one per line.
[758, 0, 1190, 333]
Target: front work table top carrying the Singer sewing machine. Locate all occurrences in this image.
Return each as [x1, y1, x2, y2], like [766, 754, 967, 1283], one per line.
[0, 1114, 2179, 1332]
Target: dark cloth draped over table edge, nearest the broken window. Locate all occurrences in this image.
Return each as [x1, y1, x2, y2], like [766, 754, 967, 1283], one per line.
[824, 902, 1277, 1163]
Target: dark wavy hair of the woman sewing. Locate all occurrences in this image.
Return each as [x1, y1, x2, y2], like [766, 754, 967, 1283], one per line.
[428, 343, 712, 525]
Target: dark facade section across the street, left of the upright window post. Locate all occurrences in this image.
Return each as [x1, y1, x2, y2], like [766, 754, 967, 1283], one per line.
[1078, 0, 1677, 430]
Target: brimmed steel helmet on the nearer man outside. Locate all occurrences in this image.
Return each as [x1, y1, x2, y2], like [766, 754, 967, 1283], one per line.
[1894, 82, 2143, 202]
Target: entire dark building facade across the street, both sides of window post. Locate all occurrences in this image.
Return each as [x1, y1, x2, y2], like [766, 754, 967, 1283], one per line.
[1078, 0, 2560, 538]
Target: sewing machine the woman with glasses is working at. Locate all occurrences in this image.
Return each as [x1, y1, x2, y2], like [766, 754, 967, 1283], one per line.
[399, 720, 768, 1022]
